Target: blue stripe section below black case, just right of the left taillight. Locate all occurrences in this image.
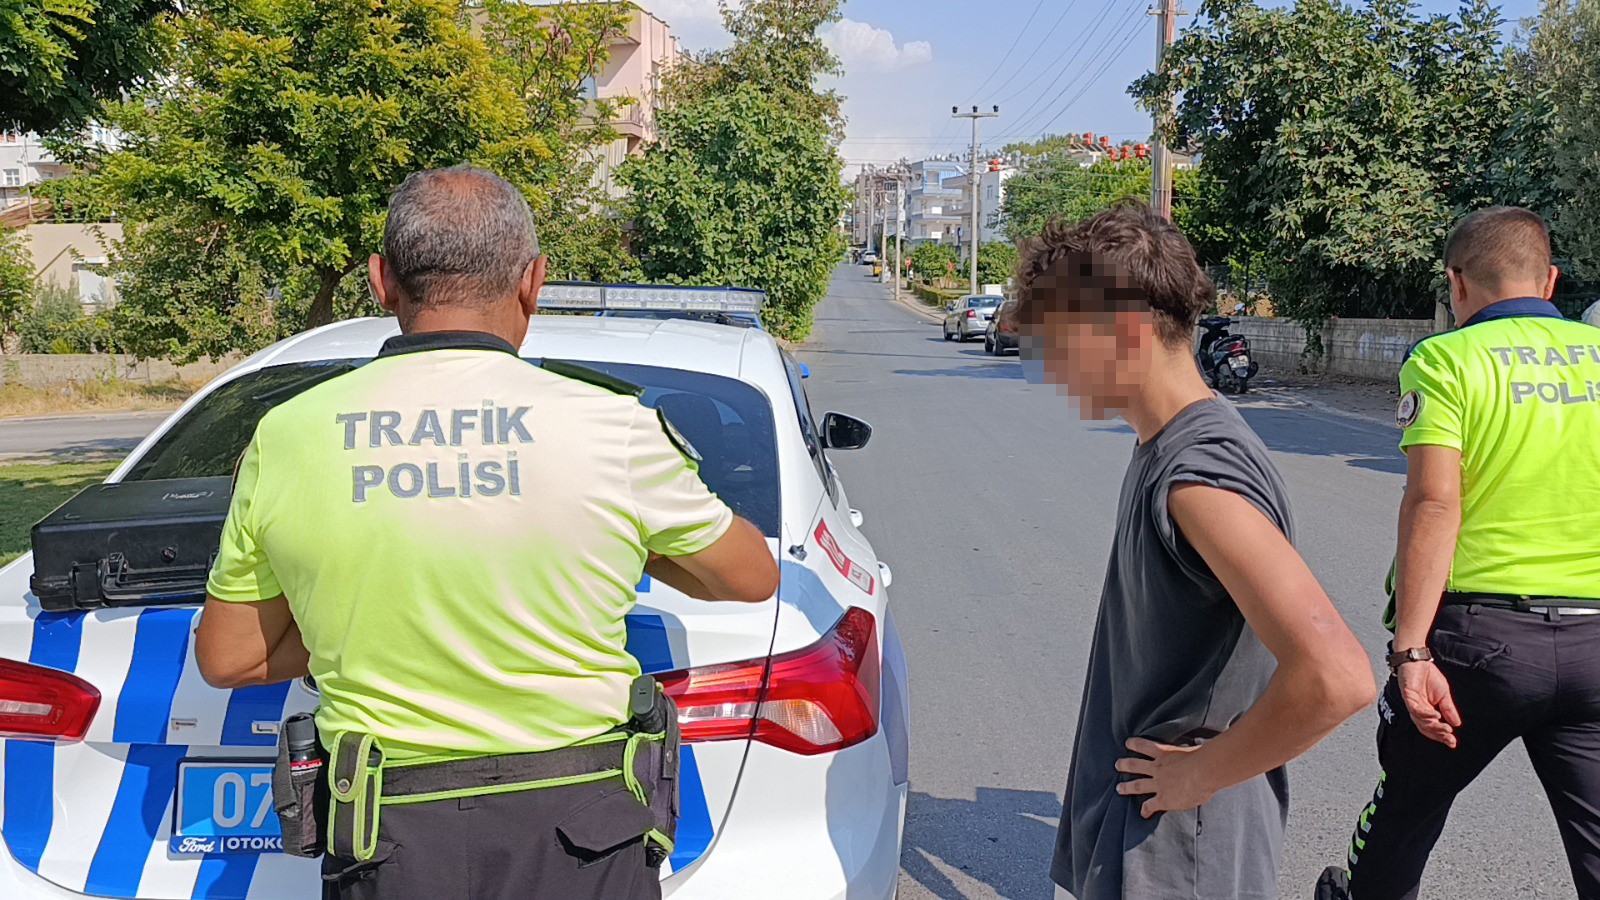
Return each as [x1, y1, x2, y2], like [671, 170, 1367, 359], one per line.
[110, 609, 195, 743]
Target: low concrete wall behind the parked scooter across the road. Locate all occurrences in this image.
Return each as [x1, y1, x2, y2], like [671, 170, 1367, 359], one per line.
[1203, 315, 1434, 381]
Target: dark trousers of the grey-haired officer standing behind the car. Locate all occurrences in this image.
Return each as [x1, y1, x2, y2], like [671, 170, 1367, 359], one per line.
[322, 777, 661, 900]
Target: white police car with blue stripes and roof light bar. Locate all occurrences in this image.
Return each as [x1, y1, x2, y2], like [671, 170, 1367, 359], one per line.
[0, 285, 909, 900]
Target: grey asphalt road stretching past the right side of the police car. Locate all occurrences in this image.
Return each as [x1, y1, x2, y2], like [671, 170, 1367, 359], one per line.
[798, 266, 1573, 900]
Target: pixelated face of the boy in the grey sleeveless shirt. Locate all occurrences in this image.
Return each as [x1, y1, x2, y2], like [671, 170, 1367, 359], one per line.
[1018, 255, 1157, 420]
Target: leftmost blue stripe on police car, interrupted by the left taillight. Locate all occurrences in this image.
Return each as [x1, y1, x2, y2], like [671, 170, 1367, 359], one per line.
[0, 612, 83, 871]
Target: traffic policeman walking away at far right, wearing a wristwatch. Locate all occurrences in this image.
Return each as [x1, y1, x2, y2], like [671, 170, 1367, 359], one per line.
[1318, 207, 1600, 900]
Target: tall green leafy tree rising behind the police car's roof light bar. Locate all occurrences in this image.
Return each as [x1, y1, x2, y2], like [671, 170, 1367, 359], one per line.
[621, 0, 845, 340]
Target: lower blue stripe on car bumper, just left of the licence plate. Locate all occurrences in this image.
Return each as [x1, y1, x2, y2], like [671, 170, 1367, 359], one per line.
[83, 739, 194, 897]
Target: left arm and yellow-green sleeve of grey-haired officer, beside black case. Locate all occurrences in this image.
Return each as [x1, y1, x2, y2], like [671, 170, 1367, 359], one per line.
[195, 434, 309, 687]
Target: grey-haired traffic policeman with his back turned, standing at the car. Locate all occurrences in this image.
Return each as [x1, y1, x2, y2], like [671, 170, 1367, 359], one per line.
[195, 167, 778, 900]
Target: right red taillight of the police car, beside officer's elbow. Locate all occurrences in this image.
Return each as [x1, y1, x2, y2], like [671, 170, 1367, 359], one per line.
[658, 609, 882, 756]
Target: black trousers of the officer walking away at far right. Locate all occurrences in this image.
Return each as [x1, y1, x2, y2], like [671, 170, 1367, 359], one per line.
[1349, 605, 1600, 900]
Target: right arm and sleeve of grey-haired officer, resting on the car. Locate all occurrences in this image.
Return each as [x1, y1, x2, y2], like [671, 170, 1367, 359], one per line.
[629, 407, 778, 604]
